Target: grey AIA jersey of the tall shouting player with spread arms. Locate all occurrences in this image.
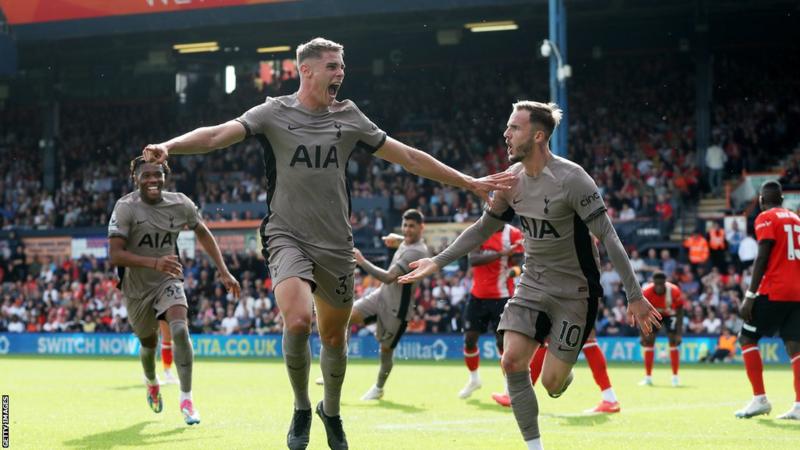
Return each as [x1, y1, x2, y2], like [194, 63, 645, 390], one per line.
[236, 93, 386, 250]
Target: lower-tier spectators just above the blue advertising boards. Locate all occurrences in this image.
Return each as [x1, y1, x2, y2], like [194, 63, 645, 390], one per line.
[0, 220, 754, 342]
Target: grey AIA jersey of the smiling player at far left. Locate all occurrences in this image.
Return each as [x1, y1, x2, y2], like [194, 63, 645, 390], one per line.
[108, 191, 201, 299]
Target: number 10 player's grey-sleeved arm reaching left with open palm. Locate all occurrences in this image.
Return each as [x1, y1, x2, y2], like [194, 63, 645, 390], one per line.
[397, 211, 506, 284]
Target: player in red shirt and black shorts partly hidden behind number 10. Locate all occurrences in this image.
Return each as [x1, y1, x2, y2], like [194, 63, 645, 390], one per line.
[458, 224, 523, 398]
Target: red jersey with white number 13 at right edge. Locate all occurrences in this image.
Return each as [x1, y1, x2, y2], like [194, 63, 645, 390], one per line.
[756, 208, 800, 302]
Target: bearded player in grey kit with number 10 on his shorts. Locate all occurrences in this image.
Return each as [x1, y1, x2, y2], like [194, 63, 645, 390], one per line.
[398, 101, 661, 449]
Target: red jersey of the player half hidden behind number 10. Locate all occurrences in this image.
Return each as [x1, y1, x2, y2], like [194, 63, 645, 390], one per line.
[470, 225, 523, 299]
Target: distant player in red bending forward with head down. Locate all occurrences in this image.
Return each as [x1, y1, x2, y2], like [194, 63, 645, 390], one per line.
[639, 271, 685, 386]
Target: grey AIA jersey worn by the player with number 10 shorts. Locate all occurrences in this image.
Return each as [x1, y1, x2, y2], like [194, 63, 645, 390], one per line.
[489, 155, 606, 298]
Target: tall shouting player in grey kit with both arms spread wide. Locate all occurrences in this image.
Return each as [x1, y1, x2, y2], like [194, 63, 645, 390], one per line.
[143, 38, 511, 449]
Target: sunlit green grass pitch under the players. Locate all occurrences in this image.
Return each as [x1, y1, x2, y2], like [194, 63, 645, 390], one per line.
[0, 356, 800, 450]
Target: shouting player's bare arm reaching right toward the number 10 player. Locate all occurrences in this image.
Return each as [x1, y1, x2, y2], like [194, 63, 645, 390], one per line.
[375, 136, 516, 204]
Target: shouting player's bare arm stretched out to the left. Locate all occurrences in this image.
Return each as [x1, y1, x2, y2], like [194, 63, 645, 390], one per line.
[142, 120, 247, 163]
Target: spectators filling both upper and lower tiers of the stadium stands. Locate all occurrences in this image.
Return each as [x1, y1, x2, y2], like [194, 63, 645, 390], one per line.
[0, 50, 800, 344]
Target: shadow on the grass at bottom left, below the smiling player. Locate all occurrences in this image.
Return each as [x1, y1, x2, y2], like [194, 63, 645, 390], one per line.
[64, 420, 187, 449]
